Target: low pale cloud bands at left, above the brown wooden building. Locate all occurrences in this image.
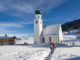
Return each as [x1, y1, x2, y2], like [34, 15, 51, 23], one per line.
[0, 23, 23, 34]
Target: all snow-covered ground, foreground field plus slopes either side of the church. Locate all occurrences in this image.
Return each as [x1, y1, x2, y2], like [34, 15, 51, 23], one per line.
[0, 32, 80, 60]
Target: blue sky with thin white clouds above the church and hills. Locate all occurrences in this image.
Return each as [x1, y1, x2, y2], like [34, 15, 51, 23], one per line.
[0, 0, 80, 35]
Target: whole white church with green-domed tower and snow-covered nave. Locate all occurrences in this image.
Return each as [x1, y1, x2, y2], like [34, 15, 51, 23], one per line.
[34, 9, 63, 44]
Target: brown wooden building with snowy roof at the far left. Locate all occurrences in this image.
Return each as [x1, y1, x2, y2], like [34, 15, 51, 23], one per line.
[0, 35, 17, 45]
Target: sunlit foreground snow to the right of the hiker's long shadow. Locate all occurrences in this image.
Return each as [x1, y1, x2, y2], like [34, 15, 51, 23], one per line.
[53, 47, 80, 60]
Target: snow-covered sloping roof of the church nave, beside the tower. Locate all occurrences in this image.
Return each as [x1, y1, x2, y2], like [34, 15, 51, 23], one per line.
[42, 24, 61, 35]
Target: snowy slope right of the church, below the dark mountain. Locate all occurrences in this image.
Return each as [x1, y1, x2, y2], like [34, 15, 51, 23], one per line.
[63, 29, 80, 45]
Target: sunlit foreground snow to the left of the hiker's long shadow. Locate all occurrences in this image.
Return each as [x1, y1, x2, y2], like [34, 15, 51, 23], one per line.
[0, 46, 49, 60]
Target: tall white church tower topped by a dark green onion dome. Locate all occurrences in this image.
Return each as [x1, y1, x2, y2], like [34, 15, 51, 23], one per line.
[34, 9, 42, 44]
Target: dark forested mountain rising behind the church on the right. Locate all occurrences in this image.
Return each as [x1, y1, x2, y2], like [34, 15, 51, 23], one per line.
[62, 19, 80, 31]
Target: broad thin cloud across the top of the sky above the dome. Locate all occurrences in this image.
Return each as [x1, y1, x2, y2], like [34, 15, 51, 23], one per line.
[0, 0, 69, 16]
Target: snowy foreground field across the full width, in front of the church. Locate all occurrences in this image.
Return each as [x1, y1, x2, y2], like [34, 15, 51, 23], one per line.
[0, 45, 80, 60]
